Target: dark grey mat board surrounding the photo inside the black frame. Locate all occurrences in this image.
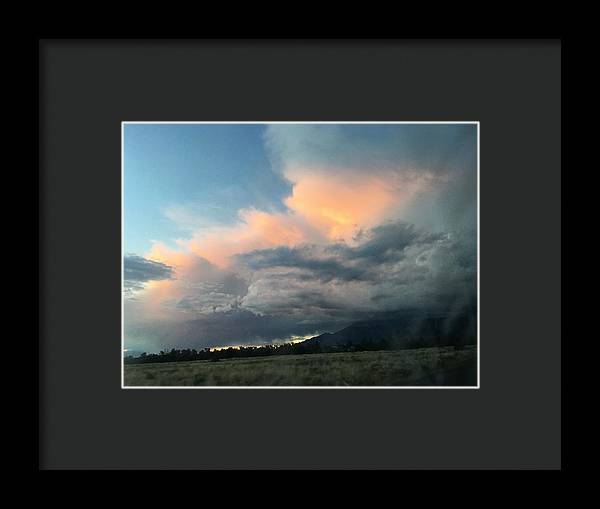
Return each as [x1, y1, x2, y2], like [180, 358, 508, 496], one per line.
[38, 38, 564, 470]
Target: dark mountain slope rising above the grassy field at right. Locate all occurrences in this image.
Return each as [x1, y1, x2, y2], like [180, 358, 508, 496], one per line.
[303, 309, 477, 348]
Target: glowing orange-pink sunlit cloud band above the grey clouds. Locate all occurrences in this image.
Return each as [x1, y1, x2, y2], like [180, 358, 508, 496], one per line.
[157, 167, 442, 268]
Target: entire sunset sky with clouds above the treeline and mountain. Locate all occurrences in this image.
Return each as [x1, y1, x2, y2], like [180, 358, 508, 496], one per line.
[123, 123, 477, 352]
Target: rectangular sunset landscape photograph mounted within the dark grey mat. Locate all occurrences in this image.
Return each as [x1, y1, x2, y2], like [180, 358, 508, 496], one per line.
[122, 120, 481, 389]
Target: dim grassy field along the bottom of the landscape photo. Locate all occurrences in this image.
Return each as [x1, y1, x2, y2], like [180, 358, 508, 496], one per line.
[125, 346, 477, 386]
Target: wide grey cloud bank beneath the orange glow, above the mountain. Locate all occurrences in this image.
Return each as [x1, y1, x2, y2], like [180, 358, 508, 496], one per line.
[126, 221, 476, 347]
